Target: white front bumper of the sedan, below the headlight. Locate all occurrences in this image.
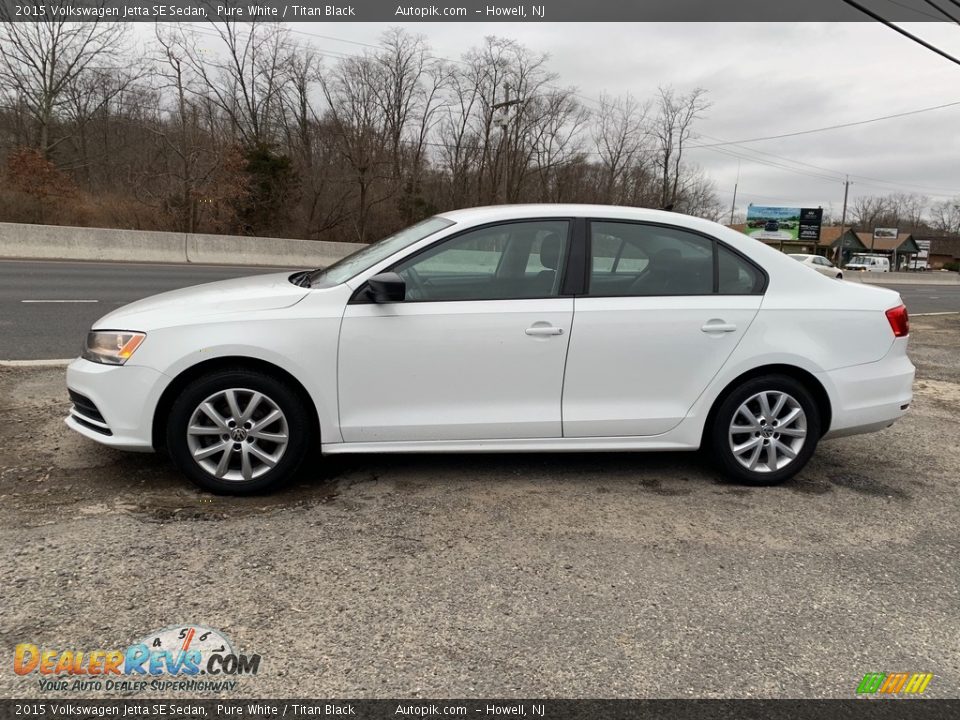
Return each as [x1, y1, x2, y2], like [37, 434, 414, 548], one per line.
[65, 358, 169, 452]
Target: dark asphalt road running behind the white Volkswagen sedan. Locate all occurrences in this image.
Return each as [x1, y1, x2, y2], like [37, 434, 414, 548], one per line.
[0, 260, 960, 360]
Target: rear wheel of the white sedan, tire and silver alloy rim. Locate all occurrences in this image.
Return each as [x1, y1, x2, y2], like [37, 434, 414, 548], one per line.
[710, 375, 821, 485]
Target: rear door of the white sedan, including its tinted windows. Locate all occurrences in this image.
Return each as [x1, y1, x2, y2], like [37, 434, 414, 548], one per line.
[563, 220, 766, 437]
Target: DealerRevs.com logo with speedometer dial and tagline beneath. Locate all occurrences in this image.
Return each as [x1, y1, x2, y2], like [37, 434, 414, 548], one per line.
[13, 624, 260, 693]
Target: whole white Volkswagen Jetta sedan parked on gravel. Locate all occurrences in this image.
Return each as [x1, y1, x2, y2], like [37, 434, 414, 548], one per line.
[67, 205, 914, 493]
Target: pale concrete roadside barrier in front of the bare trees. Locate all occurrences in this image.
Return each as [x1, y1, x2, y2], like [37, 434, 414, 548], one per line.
[0, 223, 364, 267]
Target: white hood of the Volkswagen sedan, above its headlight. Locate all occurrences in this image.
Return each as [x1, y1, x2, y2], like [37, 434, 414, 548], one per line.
[93, 272, 309, 331]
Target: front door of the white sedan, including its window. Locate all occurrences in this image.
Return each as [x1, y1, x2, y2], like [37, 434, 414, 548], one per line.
[338, 218, 573, 442]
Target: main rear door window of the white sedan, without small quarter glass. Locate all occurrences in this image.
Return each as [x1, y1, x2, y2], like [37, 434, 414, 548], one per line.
[589, 221, 713, 296]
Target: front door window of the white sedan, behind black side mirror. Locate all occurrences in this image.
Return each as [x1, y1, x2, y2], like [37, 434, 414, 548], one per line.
[393, 220, 570, 302]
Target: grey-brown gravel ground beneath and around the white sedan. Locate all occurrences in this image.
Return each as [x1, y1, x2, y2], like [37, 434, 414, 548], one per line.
[0, 315, 960, 698]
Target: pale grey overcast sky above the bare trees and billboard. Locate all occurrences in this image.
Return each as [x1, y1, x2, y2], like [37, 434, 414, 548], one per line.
[165, 22, 960, 215]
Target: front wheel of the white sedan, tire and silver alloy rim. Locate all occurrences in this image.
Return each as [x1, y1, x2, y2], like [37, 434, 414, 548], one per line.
[166, 368, 314, 495]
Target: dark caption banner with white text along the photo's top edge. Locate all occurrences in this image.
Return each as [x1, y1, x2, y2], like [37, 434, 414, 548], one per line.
[0, 0, 950, 23]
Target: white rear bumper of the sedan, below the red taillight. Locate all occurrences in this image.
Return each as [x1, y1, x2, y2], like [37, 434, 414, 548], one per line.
[822, 338, 916, 439]
